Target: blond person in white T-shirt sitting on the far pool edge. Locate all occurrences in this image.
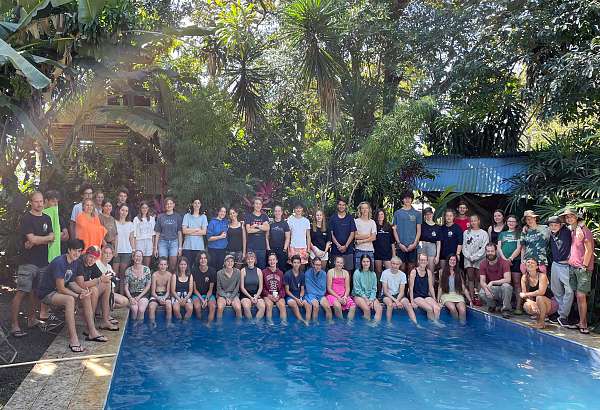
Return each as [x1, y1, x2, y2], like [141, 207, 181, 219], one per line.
[380, 256, 418, 325]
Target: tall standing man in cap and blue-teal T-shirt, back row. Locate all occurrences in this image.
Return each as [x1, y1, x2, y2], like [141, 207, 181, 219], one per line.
[392, 191, 423, 272]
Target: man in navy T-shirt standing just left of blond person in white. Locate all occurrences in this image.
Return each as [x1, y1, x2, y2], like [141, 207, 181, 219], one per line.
[329, 198, 356, 270]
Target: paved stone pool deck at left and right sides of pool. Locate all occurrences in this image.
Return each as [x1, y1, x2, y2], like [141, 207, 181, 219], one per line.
[4, 308, 600, 410]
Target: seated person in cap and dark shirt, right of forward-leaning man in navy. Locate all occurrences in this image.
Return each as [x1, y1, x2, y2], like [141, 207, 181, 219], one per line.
[72, 246, 119, 331]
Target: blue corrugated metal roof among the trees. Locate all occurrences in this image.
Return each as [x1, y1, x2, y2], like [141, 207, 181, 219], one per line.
[415, 155, 527, 194]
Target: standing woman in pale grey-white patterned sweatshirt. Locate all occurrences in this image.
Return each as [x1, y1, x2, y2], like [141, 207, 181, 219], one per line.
[462, 215, 489, 298]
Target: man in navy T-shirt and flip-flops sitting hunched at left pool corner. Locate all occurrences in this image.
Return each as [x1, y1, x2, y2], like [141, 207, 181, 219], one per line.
[36, 239, 107, 353]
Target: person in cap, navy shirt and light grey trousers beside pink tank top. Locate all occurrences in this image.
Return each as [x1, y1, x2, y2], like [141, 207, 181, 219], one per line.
[548, 216, 574, 328]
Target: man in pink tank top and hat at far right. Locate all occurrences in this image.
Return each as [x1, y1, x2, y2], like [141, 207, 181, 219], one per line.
[560, 208, 594, 334]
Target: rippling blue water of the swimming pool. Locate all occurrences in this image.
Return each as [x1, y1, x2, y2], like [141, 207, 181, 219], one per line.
[106, 312, 600, 410]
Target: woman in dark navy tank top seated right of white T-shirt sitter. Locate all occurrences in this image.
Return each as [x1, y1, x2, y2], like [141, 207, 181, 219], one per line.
[408, 253, 443, 326]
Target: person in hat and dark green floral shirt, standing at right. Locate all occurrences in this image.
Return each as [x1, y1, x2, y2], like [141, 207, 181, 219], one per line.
[520, 210, 550, 274]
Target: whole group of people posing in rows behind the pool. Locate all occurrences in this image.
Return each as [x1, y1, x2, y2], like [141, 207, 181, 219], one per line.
[11, 185, 594, 352]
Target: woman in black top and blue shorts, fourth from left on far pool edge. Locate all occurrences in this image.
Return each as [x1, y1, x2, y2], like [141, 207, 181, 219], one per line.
[192, 251, 217, 323]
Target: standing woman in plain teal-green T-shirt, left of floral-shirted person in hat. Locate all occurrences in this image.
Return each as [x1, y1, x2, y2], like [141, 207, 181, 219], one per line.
[497, 215, 524, 315]
